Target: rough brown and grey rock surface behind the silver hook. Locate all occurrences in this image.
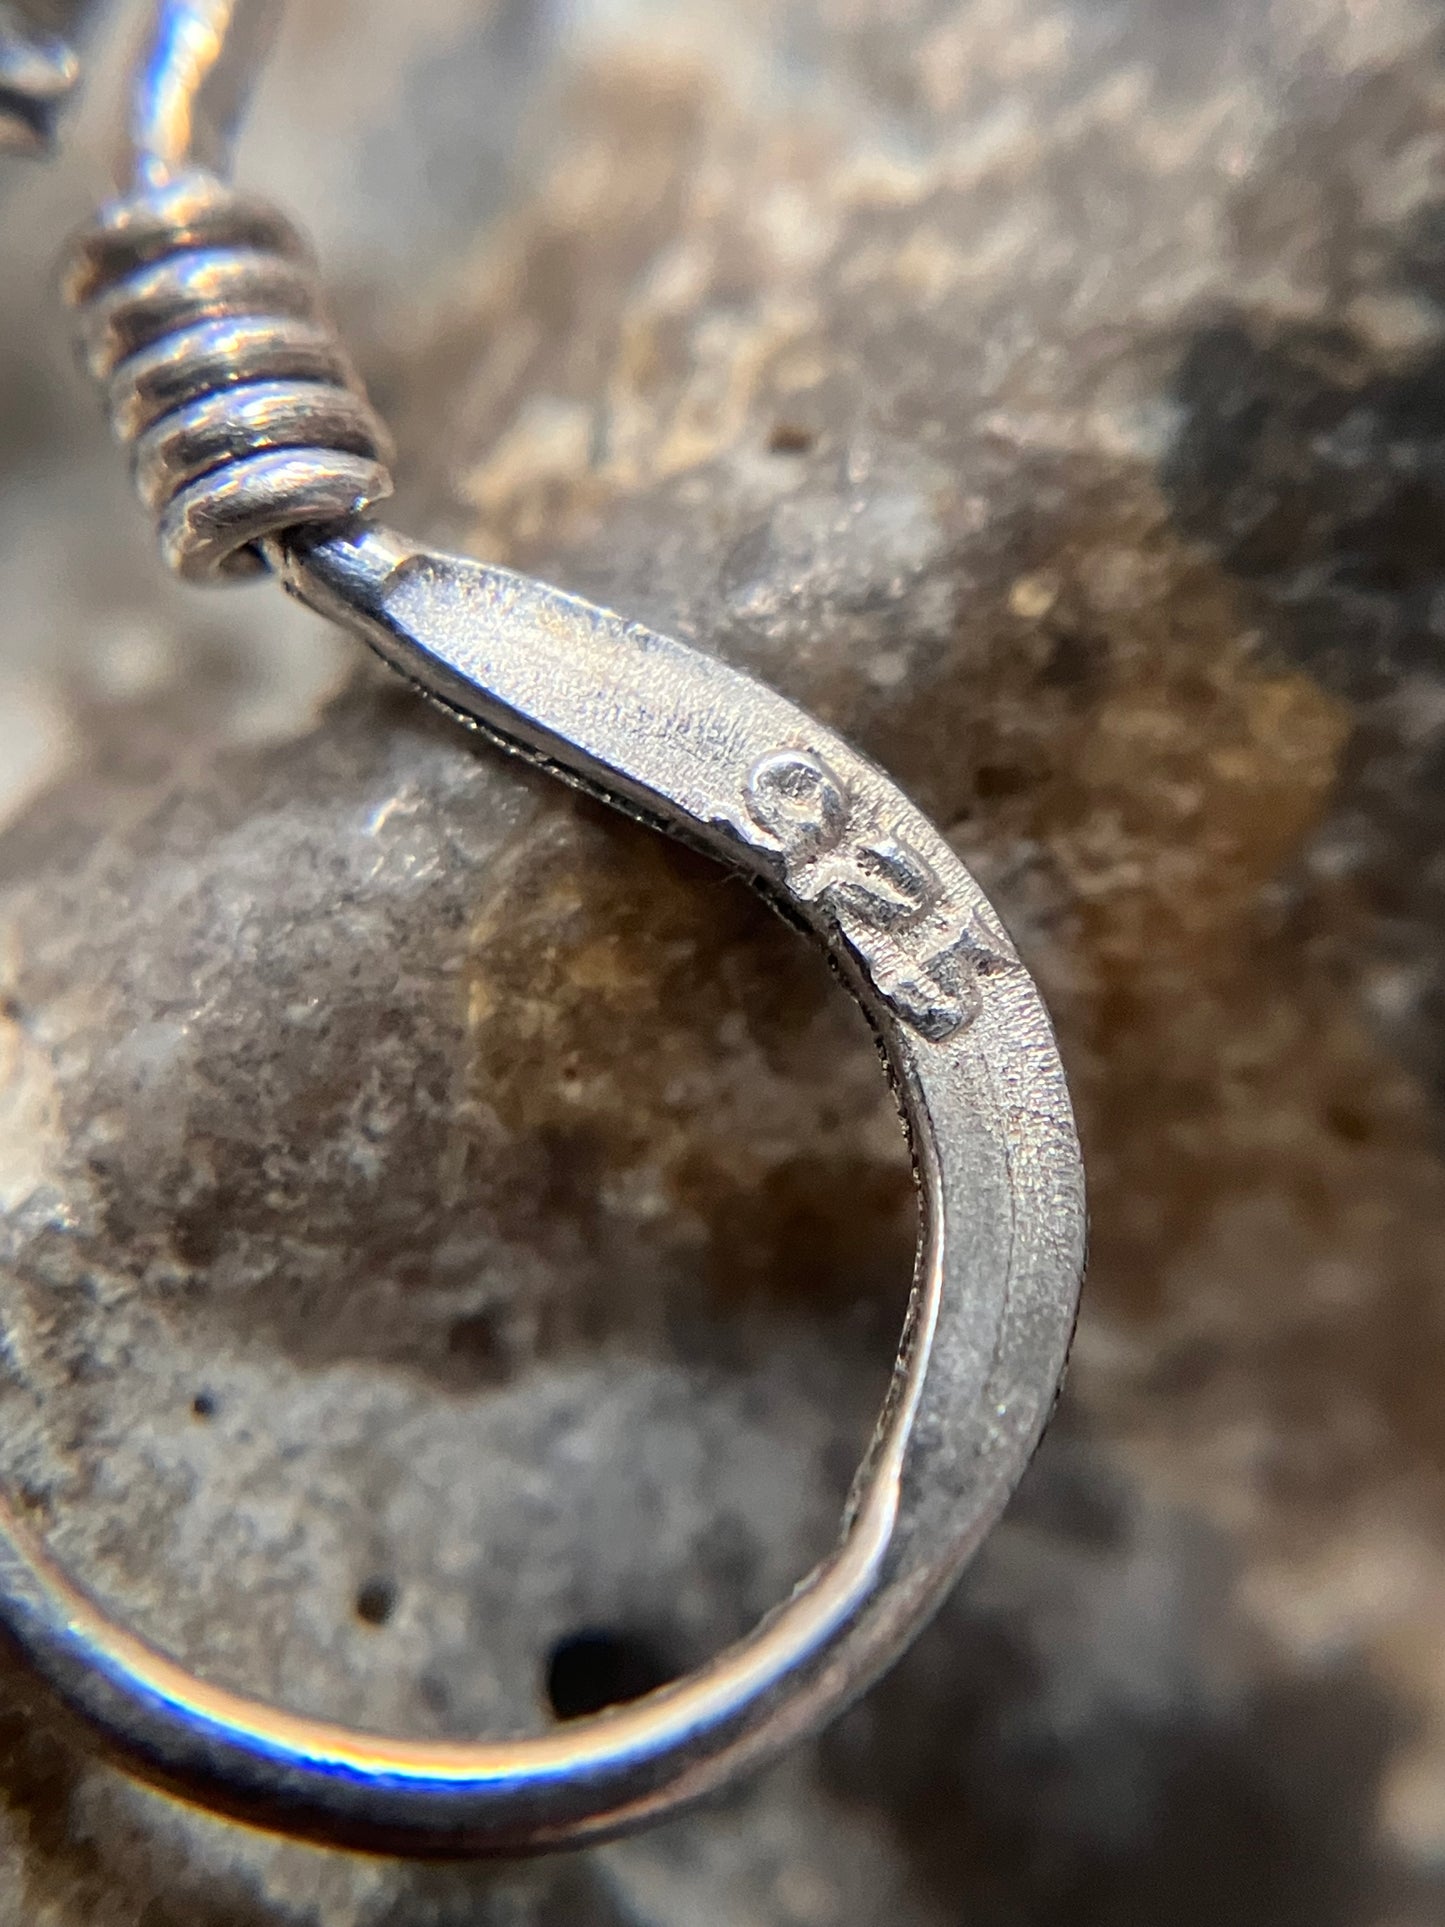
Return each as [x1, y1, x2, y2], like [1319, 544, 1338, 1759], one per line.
[0, 0, 1445, 1927]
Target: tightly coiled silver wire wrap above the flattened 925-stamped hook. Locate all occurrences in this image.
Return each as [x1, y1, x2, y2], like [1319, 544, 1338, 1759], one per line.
[64, 170, 391, 580]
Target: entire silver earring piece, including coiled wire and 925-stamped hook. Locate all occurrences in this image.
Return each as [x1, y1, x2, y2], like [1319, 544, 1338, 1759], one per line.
[0, 0, 1085, 1854]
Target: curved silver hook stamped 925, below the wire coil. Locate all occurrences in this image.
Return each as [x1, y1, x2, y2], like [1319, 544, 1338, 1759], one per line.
[0, 526, 1085, 1854]
